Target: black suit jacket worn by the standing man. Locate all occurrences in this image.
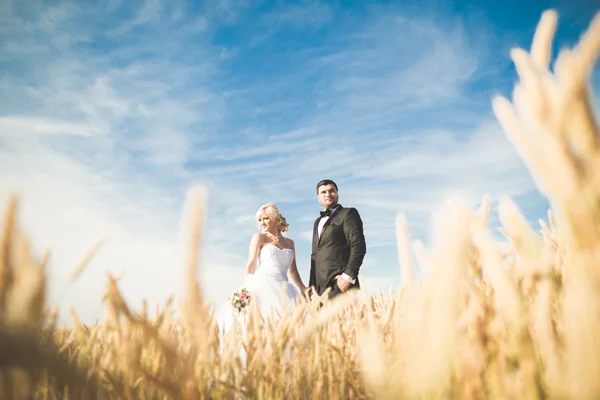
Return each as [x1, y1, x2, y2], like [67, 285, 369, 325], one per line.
[309, 205, 367, 296]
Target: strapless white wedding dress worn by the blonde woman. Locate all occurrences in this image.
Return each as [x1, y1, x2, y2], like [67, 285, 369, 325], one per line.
[217, 244, 302, 335]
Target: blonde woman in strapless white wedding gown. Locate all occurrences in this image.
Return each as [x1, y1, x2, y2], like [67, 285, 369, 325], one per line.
[217, 203, 307, 335]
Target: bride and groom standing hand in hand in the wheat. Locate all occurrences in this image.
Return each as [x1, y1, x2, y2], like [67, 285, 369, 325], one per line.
[219, 179, 366, 325]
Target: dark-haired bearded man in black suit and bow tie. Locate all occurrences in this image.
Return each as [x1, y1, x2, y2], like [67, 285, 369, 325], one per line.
[309, 179, 367, 298]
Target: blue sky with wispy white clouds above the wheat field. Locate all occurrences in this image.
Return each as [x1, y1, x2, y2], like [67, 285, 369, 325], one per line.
[0, 0, 600, 322]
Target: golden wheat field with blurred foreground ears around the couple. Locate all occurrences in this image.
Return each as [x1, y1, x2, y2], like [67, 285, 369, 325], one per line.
[0, 10, 600, 399]
